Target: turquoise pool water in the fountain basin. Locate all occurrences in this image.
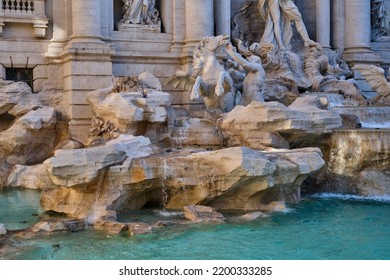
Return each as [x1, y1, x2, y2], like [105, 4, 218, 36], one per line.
[0, 191, 390, 260]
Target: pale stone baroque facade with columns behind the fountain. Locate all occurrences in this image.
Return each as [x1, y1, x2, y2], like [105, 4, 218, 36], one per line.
[0, 0, 390, 139]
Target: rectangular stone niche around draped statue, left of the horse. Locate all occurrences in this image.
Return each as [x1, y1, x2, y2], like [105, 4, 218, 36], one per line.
[114, 0, 162, 33]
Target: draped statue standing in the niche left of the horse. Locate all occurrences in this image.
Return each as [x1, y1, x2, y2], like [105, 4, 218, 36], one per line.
[121, 0, 159, 24]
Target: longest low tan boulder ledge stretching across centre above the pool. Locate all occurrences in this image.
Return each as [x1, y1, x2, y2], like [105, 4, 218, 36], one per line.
[41, 147, 324, 223]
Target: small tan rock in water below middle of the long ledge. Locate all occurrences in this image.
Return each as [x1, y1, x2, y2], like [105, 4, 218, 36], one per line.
[184, 205, 225, 223]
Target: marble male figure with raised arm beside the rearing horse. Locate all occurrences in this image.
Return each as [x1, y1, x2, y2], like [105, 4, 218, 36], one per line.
[226, 44, 265, 105]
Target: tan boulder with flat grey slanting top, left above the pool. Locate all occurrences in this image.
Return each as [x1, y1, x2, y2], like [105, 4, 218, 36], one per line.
[40, 135, 153, 223]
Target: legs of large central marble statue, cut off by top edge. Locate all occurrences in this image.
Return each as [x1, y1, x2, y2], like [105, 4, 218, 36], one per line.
[258, 0, 317, 50]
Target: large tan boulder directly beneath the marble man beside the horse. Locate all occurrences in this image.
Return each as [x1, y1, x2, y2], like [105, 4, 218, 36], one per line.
[219, 99, 342, 149]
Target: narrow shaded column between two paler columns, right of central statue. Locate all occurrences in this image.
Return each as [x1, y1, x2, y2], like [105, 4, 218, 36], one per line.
[331, 0, 345, 54]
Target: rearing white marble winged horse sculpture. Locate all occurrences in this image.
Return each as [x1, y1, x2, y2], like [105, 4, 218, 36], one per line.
[166, 35, 240, 112]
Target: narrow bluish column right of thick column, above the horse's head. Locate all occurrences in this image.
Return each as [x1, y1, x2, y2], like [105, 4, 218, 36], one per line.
[214, 0, 230, 36]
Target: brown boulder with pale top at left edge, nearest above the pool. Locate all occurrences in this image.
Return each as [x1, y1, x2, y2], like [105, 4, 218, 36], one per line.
[0, 107, 56, 164]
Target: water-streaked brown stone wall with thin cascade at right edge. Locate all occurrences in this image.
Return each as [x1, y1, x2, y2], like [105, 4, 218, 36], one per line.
[328, 129, 390, 196]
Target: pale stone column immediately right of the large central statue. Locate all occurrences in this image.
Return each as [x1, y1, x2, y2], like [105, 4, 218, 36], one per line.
[316, 0, 330, 49]
